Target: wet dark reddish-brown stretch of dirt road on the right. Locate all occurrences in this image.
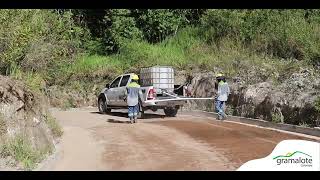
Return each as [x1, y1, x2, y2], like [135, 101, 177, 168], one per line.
[152, 119, 315, 167]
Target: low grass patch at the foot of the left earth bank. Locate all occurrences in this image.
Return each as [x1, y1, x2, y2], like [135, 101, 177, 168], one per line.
[0, 135, 52, 170]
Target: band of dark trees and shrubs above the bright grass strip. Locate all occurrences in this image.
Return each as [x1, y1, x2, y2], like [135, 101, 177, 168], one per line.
[0, 9, 320, 73]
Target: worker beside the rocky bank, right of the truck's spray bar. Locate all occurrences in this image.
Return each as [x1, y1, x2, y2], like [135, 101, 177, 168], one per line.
[215, 73, 230, 120]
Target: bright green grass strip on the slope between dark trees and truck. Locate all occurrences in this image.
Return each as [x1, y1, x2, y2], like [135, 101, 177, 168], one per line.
[57, 28, 308, 84]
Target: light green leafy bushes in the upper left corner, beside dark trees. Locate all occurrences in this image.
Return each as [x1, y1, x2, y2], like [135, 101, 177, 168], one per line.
[0, 9, 86, 74]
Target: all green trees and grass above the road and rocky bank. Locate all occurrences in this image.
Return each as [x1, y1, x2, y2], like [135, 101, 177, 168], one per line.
[0, 9, 320, 86]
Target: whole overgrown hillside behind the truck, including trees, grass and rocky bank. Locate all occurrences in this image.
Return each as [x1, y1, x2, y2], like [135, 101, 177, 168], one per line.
[0, 9, 320, 126]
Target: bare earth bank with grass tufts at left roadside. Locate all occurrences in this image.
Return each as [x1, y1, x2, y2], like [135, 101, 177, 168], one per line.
[0, 76, 63, 170]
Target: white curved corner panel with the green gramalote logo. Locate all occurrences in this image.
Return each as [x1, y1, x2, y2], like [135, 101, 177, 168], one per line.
[237, 139, 320, 171]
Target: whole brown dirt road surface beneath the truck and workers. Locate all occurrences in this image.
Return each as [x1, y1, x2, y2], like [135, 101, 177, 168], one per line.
[39, 108, 318, 170]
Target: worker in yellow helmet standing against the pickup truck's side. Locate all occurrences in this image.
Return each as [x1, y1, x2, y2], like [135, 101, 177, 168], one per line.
[126, 74, 142, 123]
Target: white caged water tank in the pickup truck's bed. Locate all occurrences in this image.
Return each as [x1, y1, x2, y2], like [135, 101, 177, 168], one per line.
[140, 66, 174, 94]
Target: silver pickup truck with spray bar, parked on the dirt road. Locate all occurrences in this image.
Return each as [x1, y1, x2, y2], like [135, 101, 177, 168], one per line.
[98, 67, 211, 118]
